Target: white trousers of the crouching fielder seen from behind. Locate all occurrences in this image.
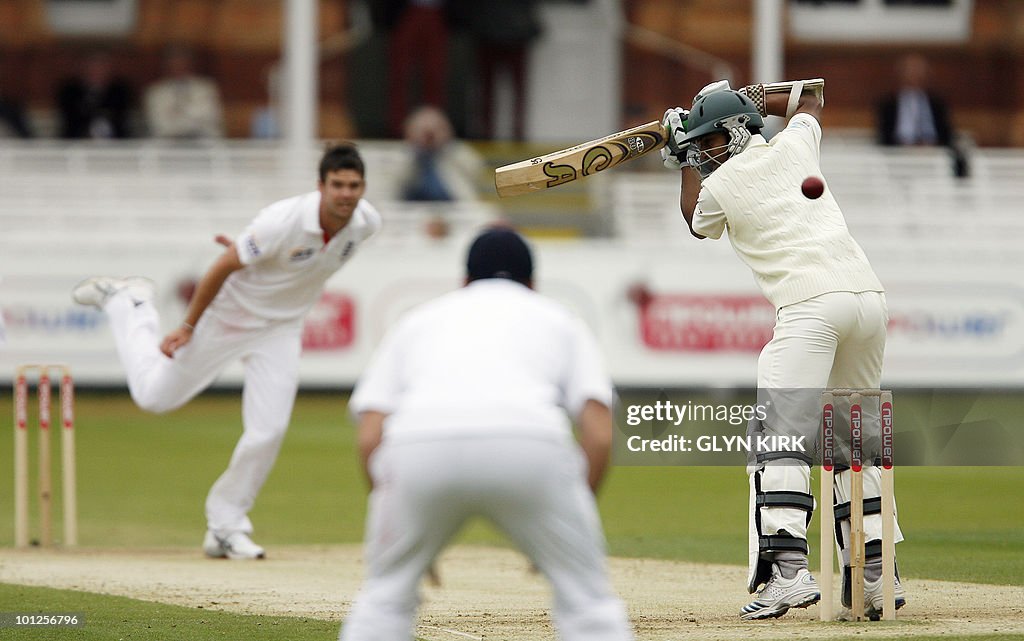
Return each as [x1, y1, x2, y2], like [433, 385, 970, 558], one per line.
[340, 435, 633, 641]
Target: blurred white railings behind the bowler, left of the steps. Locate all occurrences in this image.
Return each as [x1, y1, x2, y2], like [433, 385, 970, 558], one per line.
[0, 141, 498, 245]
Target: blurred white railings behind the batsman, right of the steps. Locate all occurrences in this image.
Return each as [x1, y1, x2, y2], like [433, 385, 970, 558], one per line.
[610, 144, 1024, 262]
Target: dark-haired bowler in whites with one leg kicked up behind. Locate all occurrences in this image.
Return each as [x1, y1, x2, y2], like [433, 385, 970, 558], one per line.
[73, 144, 381, 559]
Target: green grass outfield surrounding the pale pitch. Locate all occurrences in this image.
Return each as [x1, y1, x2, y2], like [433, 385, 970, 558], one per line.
[0, 392, 1024, 640]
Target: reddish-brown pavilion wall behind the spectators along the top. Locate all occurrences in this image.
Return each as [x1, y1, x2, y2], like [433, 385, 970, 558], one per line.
[0, 0, 1024, 145]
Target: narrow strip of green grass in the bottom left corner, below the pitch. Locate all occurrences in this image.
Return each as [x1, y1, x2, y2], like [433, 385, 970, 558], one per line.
[0, 584, 339, 641]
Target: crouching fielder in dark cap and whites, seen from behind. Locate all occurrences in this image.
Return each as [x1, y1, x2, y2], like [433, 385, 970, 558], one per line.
[341, 229, 633, 641]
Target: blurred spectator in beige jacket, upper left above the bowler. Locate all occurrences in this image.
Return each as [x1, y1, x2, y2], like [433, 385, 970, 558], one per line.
[145, 47, 224, 140]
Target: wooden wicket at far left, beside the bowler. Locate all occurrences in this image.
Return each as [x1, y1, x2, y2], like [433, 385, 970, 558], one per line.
[14, 365, 78, 548]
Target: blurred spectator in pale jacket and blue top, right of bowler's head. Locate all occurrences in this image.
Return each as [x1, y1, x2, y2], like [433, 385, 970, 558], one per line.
[397, 105, 483, 202]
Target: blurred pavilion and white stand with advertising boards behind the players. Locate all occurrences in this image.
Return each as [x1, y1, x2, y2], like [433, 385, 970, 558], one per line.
[0, 0, 1024, 389]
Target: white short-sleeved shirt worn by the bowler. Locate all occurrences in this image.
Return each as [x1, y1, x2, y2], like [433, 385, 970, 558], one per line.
[209, 191, 381, 328]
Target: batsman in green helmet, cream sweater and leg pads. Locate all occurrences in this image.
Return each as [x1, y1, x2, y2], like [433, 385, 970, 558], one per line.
[662, 81, 906, 619]
